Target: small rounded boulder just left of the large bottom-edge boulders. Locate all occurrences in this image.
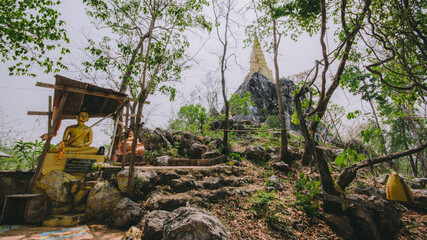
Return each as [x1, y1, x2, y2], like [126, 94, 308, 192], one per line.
[110, 198, 142, 228]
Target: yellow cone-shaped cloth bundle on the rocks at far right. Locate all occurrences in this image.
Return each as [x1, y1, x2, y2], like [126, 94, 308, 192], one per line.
[386, 172, 414, 203]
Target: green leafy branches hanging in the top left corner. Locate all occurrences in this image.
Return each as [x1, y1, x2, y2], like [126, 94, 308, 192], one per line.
[0, 0, 70, 76]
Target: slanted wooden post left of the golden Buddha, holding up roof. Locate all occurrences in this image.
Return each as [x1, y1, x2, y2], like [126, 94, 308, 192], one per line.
[28, 92, 68, 193]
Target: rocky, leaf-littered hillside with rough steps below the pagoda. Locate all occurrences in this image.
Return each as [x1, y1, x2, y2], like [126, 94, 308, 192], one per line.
[122, 126, 427, 239]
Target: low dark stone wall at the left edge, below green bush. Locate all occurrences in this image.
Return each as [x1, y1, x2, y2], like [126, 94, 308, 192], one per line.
[0, 171, 34, 214]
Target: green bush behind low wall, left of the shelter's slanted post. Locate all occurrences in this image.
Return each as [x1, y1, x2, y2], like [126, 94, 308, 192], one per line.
[13, 140, 44, 170]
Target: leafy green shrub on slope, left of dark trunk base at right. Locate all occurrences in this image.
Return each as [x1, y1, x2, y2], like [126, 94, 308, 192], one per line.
[295, 173, 321, 217]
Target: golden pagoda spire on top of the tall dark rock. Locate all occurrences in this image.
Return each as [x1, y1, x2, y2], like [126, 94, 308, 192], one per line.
[249, 34, 275, 83]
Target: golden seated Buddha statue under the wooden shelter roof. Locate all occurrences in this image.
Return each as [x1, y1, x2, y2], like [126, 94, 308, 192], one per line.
[49, 112, 98, 154]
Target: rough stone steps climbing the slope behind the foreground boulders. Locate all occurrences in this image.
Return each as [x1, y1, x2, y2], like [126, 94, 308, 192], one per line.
[138, 164, 261, 211]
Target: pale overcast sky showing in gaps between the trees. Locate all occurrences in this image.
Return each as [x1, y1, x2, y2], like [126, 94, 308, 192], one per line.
[0, 1, 354, 146]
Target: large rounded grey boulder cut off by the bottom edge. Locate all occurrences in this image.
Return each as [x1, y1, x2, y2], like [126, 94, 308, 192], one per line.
[163, 207, 229, 240]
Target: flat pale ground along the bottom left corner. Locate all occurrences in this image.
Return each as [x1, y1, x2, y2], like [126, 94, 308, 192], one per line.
[0, 225, 125, 240]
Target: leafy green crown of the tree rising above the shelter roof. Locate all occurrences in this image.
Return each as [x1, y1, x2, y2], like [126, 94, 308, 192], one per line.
[83, 0, 212, 100]
